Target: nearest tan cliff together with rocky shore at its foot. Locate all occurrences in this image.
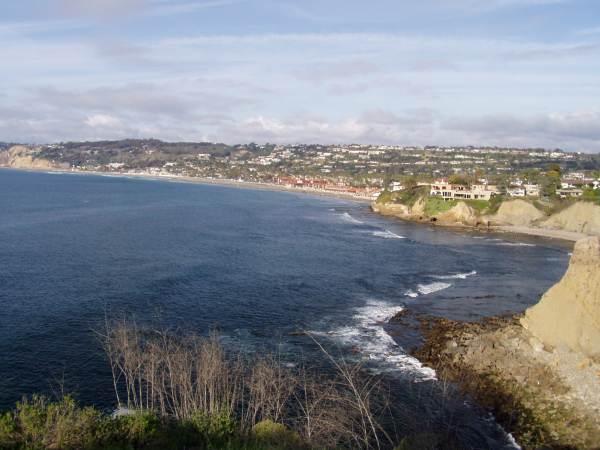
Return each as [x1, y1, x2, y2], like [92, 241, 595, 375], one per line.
[413, 237, 600, 449]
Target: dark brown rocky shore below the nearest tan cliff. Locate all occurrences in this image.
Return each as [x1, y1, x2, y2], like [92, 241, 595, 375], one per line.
[404, 310, 600, 449]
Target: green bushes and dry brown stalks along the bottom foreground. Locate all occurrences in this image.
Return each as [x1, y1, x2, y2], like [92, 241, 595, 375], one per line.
[0, 322, 464, 450]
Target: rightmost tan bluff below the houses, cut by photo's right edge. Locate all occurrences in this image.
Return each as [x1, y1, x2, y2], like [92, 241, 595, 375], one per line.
[539, 202, 600, 236]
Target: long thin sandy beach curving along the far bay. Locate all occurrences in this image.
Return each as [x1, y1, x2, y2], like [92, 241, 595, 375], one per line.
[0, 166, 372, 205]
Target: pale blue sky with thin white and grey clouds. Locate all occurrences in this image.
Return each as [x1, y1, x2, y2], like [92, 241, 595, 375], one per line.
[0, 0, 600, 152]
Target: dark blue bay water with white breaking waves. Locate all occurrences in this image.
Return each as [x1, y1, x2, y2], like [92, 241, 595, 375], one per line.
[0, 170, 569, 445]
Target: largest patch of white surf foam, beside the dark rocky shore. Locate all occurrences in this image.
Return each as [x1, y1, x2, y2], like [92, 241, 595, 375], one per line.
[315, 300, 436, 381]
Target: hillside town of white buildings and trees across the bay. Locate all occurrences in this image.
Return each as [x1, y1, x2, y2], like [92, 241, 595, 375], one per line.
[0, 139, 600, 200]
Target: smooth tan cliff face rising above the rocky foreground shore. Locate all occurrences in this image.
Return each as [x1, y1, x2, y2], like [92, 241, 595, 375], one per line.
[521, 237, 600, 360]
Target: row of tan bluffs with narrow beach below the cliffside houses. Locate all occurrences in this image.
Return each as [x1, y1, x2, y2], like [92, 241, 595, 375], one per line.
[371, 198, 600, 241]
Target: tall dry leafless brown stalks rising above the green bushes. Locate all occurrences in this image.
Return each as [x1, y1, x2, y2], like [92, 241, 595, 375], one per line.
[100, 320, 392, 448]
